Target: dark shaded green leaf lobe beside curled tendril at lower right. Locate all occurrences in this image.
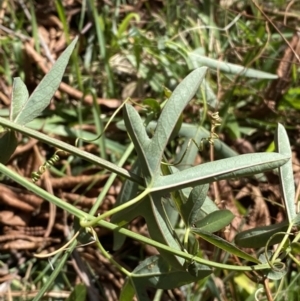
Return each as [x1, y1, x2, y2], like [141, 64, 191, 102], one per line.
[234, 221, 288, 248]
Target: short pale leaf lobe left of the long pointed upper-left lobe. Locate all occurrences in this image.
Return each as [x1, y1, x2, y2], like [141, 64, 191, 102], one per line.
[9, 77, 29, 121]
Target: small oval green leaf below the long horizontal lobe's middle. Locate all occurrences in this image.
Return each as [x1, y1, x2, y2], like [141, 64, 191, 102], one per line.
[196, 209, 234, 233]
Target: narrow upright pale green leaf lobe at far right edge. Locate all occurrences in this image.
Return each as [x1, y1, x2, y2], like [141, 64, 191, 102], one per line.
[275, 123, 296, 222]
